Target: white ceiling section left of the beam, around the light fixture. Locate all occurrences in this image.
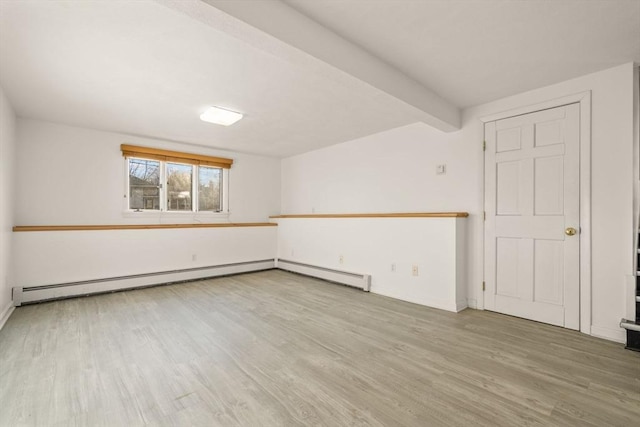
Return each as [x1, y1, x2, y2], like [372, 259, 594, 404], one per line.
[0, 1, 416, 156]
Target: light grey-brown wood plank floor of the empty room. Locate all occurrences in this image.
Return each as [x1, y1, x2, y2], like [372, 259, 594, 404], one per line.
[0, 270, 640, 426]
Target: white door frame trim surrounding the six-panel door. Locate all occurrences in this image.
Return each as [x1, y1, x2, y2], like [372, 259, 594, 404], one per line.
[478, 90, 591, 335]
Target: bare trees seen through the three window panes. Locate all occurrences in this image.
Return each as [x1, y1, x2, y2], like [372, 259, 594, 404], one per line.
[129, 158, 222, 212]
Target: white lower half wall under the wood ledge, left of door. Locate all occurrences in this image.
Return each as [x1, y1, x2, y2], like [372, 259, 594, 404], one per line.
[276, 218, 467, 312]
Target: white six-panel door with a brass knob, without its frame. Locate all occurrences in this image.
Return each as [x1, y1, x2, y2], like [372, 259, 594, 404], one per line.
[485, 104, 580, 329]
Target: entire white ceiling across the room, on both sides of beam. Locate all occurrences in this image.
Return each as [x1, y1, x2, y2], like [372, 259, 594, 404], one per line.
[0, 0, 640, 157]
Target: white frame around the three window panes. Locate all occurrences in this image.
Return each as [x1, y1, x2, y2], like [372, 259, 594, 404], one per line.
[123, 157, 230, 219]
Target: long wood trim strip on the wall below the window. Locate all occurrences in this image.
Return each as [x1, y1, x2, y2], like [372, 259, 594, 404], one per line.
[13, 222, 278, 232]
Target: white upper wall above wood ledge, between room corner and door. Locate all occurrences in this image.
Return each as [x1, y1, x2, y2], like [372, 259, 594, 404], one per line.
[282, 123, 476, 214]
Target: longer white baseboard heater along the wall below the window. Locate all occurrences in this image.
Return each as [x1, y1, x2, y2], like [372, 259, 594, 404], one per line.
[13, 259, 275, 307]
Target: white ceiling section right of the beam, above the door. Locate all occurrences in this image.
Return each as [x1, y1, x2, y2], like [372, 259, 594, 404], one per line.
[284, 0, 640, 108]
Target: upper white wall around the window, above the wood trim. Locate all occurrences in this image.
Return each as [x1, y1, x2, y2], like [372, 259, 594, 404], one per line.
[16, 119, 280, 225]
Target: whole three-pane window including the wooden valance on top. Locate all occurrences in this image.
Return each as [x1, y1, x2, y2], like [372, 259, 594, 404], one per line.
[121, 144, 233, 212]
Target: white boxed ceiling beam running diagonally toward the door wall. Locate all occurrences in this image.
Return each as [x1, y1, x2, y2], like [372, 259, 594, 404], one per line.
[156, 0, 461, 132]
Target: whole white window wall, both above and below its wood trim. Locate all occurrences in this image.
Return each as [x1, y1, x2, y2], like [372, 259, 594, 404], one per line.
[12, 119, 280, 287]
